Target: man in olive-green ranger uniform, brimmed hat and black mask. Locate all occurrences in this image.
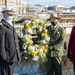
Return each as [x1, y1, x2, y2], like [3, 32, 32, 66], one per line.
[47, 13, 65, 75]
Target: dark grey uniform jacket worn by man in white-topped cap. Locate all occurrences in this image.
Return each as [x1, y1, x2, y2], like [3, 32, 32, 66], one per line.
[0, 19, 21, 62]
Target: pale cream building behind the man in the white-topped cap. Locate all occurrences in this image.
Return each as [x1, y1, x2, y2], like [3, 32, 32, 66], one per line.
[0, 0, 27, 20]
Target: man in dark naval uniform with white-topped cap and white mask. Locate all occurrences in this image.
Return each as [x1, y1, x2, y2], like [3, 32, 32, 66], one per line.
[0, 7, 21, 75]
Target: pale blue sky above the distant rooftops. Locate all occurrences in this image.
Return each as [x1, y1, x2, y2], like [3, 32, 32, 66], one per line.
[24, 0, 75, 7]
